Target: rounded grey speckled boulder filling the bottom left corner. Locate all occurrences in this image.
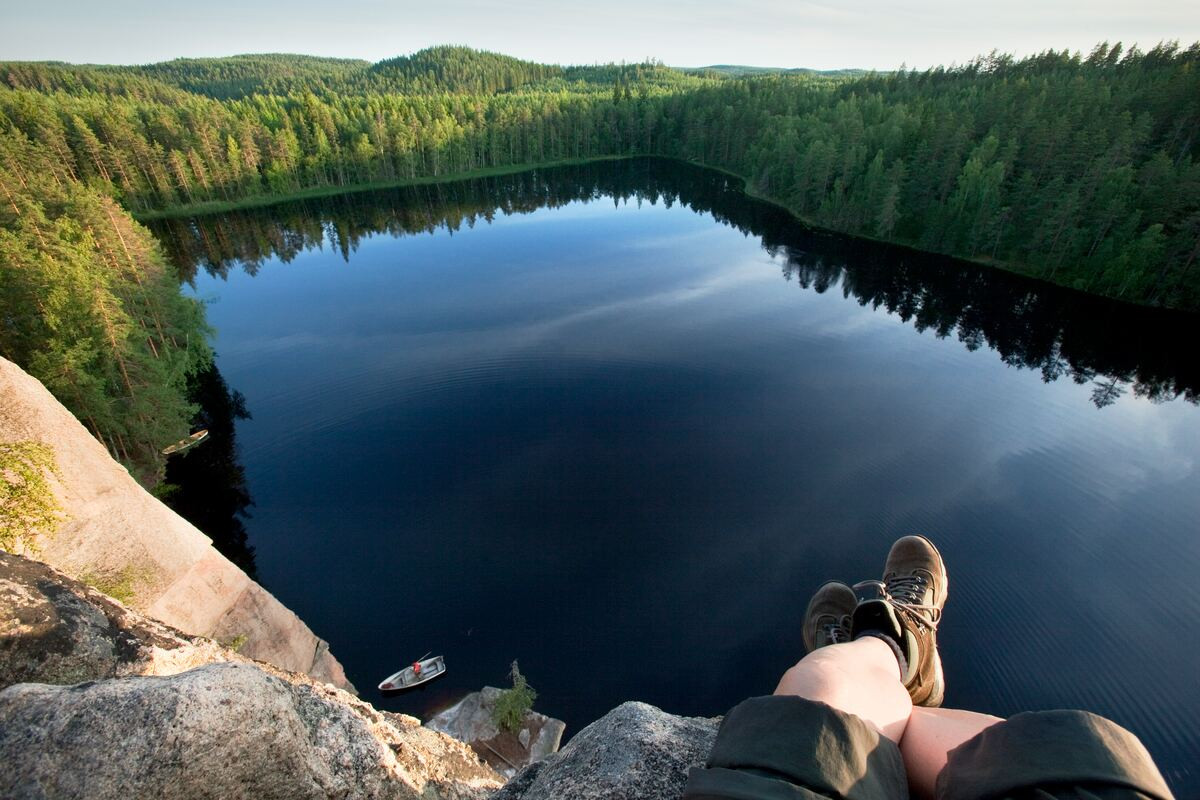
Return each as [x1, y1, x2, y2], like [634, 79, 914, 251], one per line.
[0, 663, 502, 800]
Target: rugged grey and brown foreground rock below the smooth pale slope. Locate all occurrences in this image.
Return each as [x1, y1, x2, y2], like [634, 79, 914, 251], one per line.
[0, 553, 503, 800]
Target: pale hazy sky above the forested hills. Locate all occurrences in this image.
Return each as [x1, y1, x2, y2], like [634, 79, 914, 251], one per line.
[0, 0, 1200, 70]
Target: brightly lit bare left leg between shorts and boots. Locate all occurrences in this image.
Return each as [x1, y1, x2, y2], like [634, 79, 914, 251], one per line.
[775, 637, 912, 743]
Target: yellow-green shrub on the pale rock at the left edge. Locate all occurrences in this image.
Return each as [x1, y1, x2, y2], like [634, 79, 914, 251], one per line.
[0, 441, 62, 553]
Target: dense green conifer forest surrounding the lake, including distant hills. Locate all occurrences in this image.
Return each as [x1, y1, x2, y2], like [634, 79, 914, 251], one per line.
[0, 43, 1200, 483]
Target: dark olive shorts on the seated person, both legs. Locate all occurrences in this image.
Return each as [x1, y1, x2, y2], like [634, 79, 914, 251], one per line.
[684, 697, 1171, 800]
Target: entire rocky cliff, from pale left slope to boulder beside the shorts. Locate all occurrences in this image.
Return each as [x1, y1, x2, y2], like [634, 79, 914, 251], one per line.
[0, 359, 718, 800]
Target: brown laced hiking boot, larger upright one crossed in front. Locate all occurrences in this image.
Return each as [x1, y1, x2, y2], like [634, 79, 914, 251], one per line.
[851, 536, 950, 706]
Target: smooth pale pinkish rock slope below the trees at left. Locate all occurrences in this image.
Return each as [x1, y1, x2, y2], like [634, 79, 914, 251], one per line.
[0, 359, 353, 691]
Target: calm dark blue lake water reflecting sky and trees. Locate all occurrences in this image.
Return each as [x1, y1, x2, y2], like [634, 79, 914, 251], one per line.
[158, 162, 1200, 794]
